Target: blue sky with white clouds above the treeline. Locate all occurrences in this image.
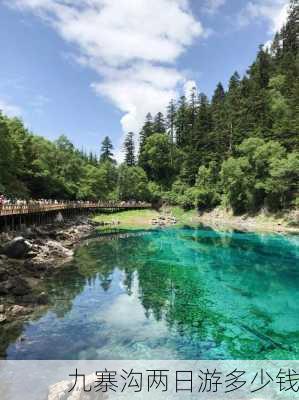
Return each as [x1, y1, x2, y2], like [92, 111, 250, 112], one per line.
[0, 0, 288, 158]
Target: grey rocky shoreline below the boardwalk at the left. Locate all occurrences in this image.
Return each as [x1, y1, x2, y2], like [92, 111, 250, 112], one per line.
[0, 217, 97, 327]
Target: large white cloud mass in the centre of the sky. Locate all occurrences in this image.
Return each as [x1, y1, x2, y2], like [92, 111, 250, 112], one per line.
[9, 0, 206, 150]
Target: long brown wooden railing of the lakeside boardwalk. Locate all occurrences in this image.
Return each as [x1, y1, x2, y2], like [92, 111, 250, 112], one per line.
[0, 202, 151, 217]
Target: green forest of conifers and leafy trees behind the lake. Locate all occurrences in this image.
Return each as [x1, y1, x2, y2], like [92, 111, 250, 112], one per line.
[0, 0, 299, 214]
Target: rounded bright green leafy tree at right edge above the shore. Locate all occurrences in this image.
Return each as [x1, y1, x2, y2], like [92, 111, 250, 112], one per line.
[221, 138, 299, 213]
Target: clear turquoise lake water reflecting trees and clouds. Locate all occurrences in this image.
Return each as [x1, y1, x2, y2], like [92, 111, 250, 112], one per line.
[2, 228, 299, 359]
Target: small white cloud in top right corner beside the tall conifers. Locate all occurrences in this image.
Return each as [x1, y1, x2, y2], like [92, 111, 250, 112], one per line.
[239, 0, 289, 34]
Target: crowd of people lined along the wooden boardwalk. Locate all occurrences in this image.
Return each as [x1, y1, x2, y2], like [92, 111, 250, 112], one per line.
[0, 195, 150, 210]
